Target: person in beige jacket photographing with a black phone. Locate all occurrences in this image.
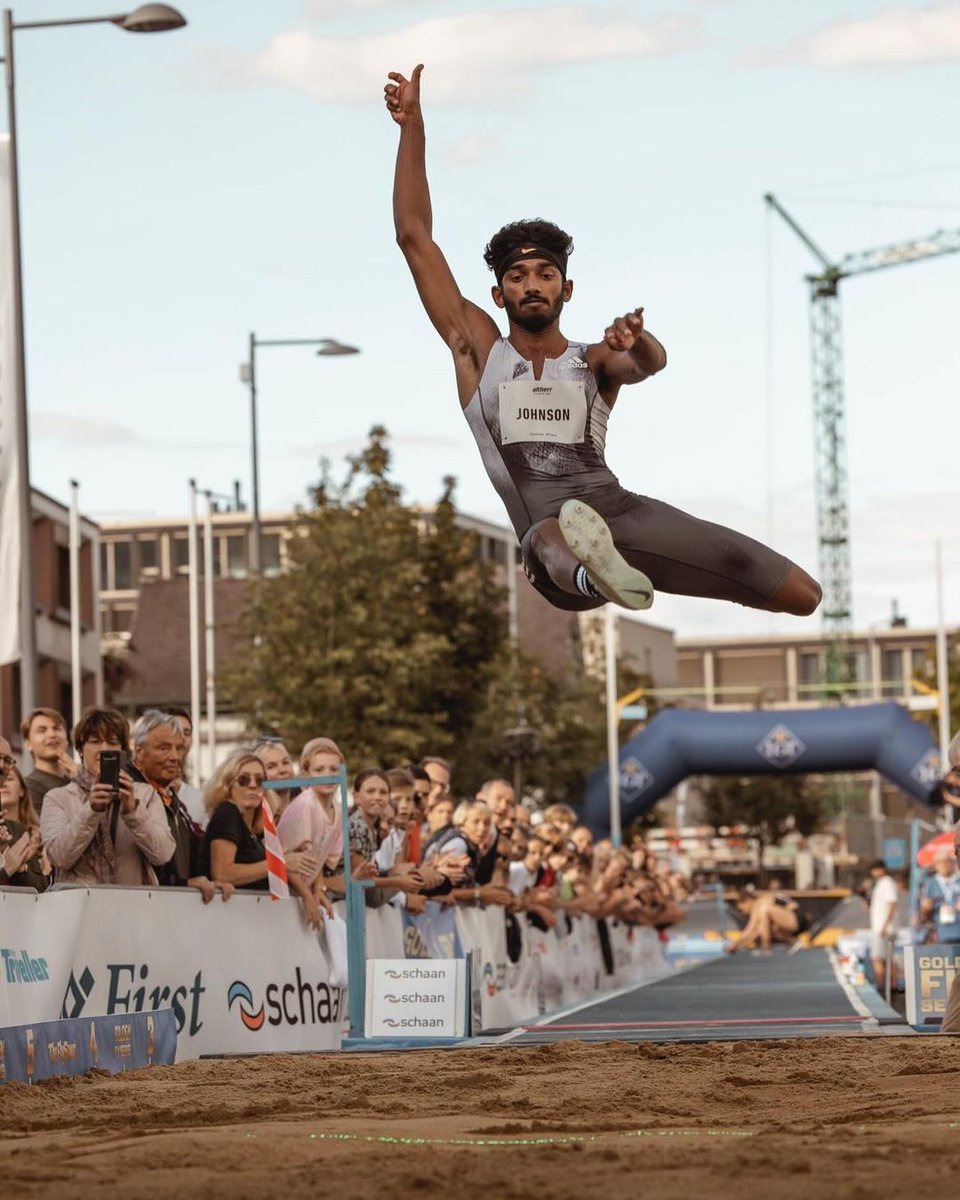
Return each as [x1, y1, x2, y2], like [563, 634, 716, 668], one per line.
[40, 708, 176, 886]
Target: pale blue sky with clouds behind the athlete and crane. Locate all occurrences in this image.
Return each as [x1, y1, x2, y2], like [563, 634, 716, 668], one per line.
[14, 0, 960, 636]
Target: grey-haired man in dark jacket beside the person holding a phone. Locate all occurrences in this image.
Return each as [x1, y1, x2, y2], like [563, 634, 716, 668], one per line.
[130, 708, 222, 901]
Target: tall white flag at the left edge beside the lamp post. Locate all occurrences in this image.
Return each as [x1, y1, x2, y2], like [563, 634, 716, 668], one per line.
[0, 134, 20, 664]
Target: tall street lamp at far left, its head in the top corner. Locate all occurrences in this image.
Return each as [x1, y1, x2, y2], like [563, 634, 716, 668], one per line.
[2, 4, 186, 713]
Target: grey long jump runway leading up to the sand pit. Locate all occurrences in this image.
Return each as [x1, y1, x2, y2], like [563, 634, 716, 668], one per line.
[504, 947, 912, 1044]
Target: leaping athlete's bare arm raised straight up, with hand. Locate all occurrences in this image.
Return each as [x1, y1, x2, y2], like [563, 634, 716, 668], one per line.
[384, 64, 499, 402]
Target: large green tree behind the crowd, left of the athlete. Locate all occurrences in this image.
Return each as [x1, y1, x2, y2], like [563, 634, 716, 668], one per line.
[224, 427, 605, 800]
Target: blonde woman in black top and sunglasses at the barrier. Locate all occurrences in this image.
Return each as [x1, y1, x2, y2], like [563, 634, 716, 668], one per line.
[199, 749, 332, 929]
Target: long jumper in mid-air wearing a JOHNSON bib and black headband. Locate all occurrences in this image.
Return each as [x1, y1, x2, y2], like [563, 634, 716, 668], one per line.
[384, 66, 821, 616]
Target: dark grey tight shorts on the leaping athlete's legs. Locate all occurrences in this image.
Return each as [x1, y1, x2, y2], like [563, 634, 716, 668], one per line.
[521, 486, 794, 612]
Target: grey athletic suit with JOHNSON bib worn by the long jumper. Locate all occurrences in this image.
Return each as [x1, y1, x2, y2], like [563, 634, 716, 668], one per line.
[464, 337, 793, 610]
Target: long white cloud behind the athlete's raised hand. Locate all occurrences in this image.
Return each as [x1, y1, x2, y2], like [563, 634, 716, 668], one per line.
[202, 5, 690, 104]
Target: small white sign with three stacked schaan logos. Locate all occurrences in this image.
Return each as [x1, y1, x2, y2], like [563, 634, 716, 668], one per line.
[365, 959, 467, 1038]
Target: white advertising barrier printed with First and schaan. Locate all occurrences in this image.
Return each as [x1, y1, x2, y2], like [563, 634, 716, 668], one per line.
[0, 888, 346, 1060]
